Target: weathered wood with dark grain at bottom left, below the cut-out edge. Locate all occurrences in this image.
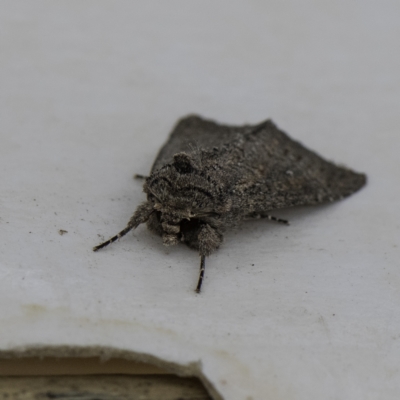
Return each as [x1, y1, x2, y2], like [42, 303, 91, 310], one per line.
[0, 375, 211, 400]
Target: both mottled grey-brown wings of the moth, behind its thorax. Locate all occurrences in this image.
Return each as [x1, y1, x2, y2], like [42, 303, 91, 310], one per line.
[152, 116, 366, 214]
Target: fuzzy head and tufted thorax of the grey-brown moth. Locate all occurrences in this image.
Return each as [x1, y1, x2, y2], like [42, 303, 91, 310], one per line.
[144, 152, 229, 245]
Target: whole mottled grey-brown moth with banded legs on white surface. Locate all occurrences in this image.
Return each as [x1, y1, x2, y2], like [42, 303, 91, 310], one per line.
[93, 115, 366, 293]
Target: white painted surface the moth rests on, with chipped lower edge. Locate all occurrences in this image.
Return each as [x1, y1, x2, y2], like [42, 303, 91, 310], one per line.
[0, 0, 400, 400]
